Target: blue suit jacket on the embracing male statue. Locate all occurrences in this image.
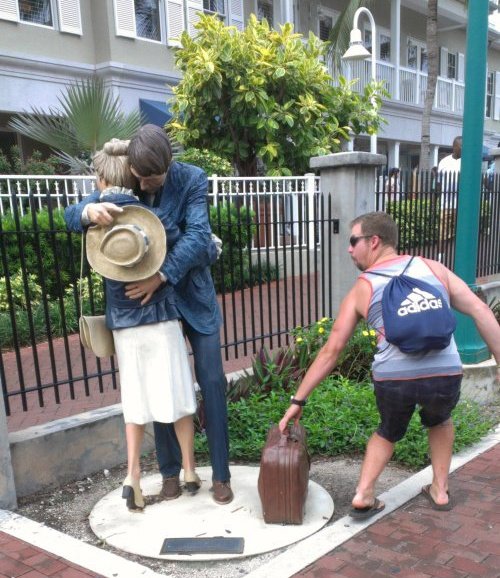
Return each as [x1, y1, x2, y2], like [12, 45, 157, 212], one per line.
[64, 161, 222, 334]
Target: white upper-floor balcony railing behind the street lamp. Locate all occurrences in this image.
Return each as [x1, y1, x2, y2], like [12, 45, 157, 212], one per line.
[330, 60, 465, 114]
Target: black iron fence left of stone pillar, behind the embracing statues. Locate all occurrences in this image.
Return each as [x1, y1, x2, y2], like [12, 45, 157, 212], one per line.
[0, 176, 333, 416]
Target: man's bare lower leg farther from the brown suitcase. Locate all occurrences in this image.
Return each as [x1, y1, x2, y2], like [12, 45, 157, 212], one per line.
[427, 419, 455, 504]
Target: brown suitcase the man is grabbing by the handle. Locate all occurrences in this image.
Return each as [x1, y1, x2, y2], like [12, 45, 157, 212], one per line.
[258, 425, 310, 524]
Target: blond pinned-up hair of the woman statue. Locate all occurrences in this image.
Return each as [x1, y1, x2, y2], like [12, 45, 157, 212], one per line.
[92, 138, 137, 189]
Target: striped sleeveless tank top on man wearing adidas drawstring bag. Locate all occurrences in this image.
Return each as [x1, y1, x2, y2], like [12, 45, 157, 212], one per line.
[361, 255, 462, 381]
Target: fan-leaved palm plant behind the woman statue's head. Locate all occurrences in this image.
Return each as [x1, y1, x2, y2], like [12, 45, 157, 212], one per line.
[9, 76, 141, 174]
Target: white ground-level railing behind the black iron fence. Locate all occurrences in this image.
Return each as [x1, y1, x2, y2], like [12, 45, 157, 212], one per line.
[0, 174, 320, 249]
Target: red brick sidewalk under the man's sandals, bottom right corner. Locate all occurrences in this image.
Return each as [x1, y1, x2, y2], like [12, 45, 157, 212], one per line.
[295, 444, 500, 578]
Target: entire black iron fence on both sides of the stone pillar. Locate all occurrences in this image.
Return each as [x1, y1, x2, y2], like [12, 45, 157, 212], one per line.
[0, 172, 500, 415]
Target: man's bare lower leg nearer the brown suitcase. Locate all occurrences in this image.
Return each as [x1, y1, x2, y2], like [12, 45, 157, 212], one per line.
[352, 432, 394, 508]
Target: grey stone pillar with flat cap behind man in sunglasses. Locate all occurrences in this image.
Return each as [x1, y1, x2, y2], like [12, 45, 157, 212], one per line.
[310, 152, 386, 318]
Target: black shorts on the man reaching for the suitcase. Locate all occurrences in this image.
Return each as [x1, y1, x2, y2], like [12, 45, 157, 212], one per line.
[373, 375, 462, 442]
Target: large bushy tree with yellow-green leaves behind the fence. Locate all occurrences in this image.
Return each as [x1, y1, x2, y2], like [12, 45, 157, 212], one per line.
[167, 15, 382, 176]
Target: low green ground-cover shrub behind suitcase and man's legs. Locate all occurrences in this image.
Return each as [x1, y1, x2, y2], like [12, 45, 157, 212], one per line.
[196, 376, 493, 468]
